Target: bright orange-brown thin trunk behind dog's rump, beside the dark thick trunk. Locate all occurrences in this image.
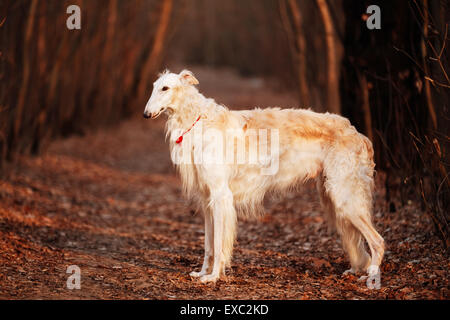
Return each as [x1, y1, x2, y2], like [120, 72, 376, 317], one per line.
[316, 0, 341, 114]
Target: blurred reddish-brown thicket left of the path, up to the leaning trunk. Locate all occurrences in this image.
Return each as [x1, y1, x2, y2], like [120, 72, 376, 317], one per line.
[0, 0, 173, 159]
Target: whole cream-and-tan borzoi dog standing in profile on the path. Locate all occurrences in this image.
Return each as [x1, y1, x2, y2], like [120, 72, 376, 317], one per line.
[144, 70, 384, 282]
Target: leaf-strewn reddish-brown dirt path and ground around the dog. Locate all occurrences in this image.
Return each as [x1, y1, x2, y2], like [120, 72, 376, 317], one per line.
[0, 68, 450, 299]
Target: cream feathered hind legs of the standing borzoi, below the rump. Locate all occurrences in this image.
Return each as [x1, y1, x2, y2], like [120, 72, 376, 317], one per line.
[325, 153, 384, 276]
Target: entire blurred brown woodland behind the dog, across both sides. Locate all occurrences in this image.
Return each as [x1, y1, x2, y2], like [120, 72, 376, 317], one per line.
[0, 0, 450, 246]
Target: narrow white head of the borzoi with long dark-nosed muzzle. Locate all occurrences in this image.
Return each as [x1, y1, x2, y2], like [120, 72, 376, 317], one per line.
[144, 70, 198, 119]
